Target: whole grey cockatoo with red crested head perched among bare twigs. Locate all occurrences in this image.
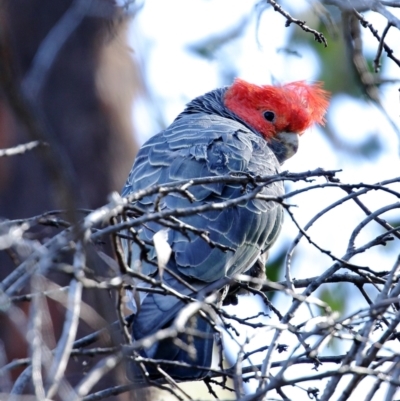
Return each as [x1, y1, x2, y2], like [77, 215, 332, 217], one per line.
[122, 79, 328, 380]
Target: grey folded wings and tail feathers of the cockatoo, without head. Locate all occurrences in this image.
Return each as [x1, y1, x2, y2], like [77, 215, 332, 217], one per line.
[122, 114, 283, 379]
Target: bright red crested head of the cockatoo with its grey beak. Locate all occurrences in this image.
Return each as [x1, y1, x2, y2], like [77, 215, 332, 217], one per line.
[224, 79, 329, 161]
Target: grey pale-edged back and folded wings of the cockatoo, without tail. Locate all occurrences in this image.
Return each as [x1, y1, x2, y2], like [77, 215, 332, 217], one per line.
[122, 114, 283, 282]
